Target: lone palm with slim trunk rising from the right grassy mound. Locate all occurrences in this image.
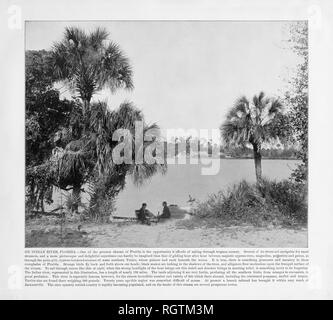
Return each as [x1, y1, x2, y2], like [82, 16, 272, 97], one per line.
[220, 92, 283, 182]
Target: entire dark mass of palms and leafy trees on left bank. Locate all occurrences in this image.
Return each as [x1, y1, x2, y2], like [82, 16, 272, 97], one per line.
[26, 28, 166, 216]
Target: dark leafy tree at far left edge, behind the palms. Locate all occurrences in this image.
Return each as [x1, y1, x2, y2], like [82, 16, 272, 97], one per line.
[25, 50, 75, 210]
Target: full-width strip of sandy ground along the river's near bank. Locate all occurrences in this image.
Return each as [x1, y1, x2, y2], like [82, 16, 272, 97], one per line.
[26, 217, 307, 248]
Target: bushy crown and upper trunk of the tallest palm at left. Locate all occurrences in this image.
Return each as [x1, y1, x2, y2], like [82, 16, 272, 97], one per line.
[51, 27, 133, 115]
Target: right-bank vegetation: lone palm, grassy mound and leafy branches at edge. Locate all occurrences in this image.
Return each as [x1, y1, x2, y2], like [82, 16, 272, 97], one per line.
[210, 22, 308, 224]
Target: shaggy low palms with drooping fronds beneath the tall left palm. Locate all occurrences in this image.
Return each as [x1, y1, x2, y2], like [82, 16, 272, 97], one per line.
[58, 102, 166, 211]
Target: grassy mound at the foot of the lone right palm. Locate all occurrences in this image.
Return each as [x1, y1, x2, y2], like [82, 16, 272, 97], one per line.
[194, 179, 307, 226]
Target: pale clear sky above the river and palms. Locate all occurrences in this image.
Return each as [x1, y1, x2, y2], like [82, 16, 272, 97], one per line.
[26, 21, 298, 130]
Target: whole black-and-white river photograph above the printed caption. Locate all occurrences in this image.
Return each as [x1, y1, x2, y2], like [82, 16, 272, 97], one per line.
[22, 20, 309, 248]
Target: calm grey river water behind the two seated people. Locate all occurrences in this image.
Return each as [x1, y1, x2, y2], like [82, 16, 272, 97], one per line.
[113, 159, 298, 216]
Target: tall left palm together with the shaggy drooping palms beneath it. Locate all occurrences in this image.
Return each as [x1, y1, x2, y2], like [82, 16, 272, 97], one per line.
[51, 27, 165, 211]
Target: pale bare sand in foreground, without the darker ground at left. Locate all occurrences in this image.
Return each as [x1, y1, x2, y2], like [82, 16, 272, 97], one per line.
[86, 220, 307, 248]
